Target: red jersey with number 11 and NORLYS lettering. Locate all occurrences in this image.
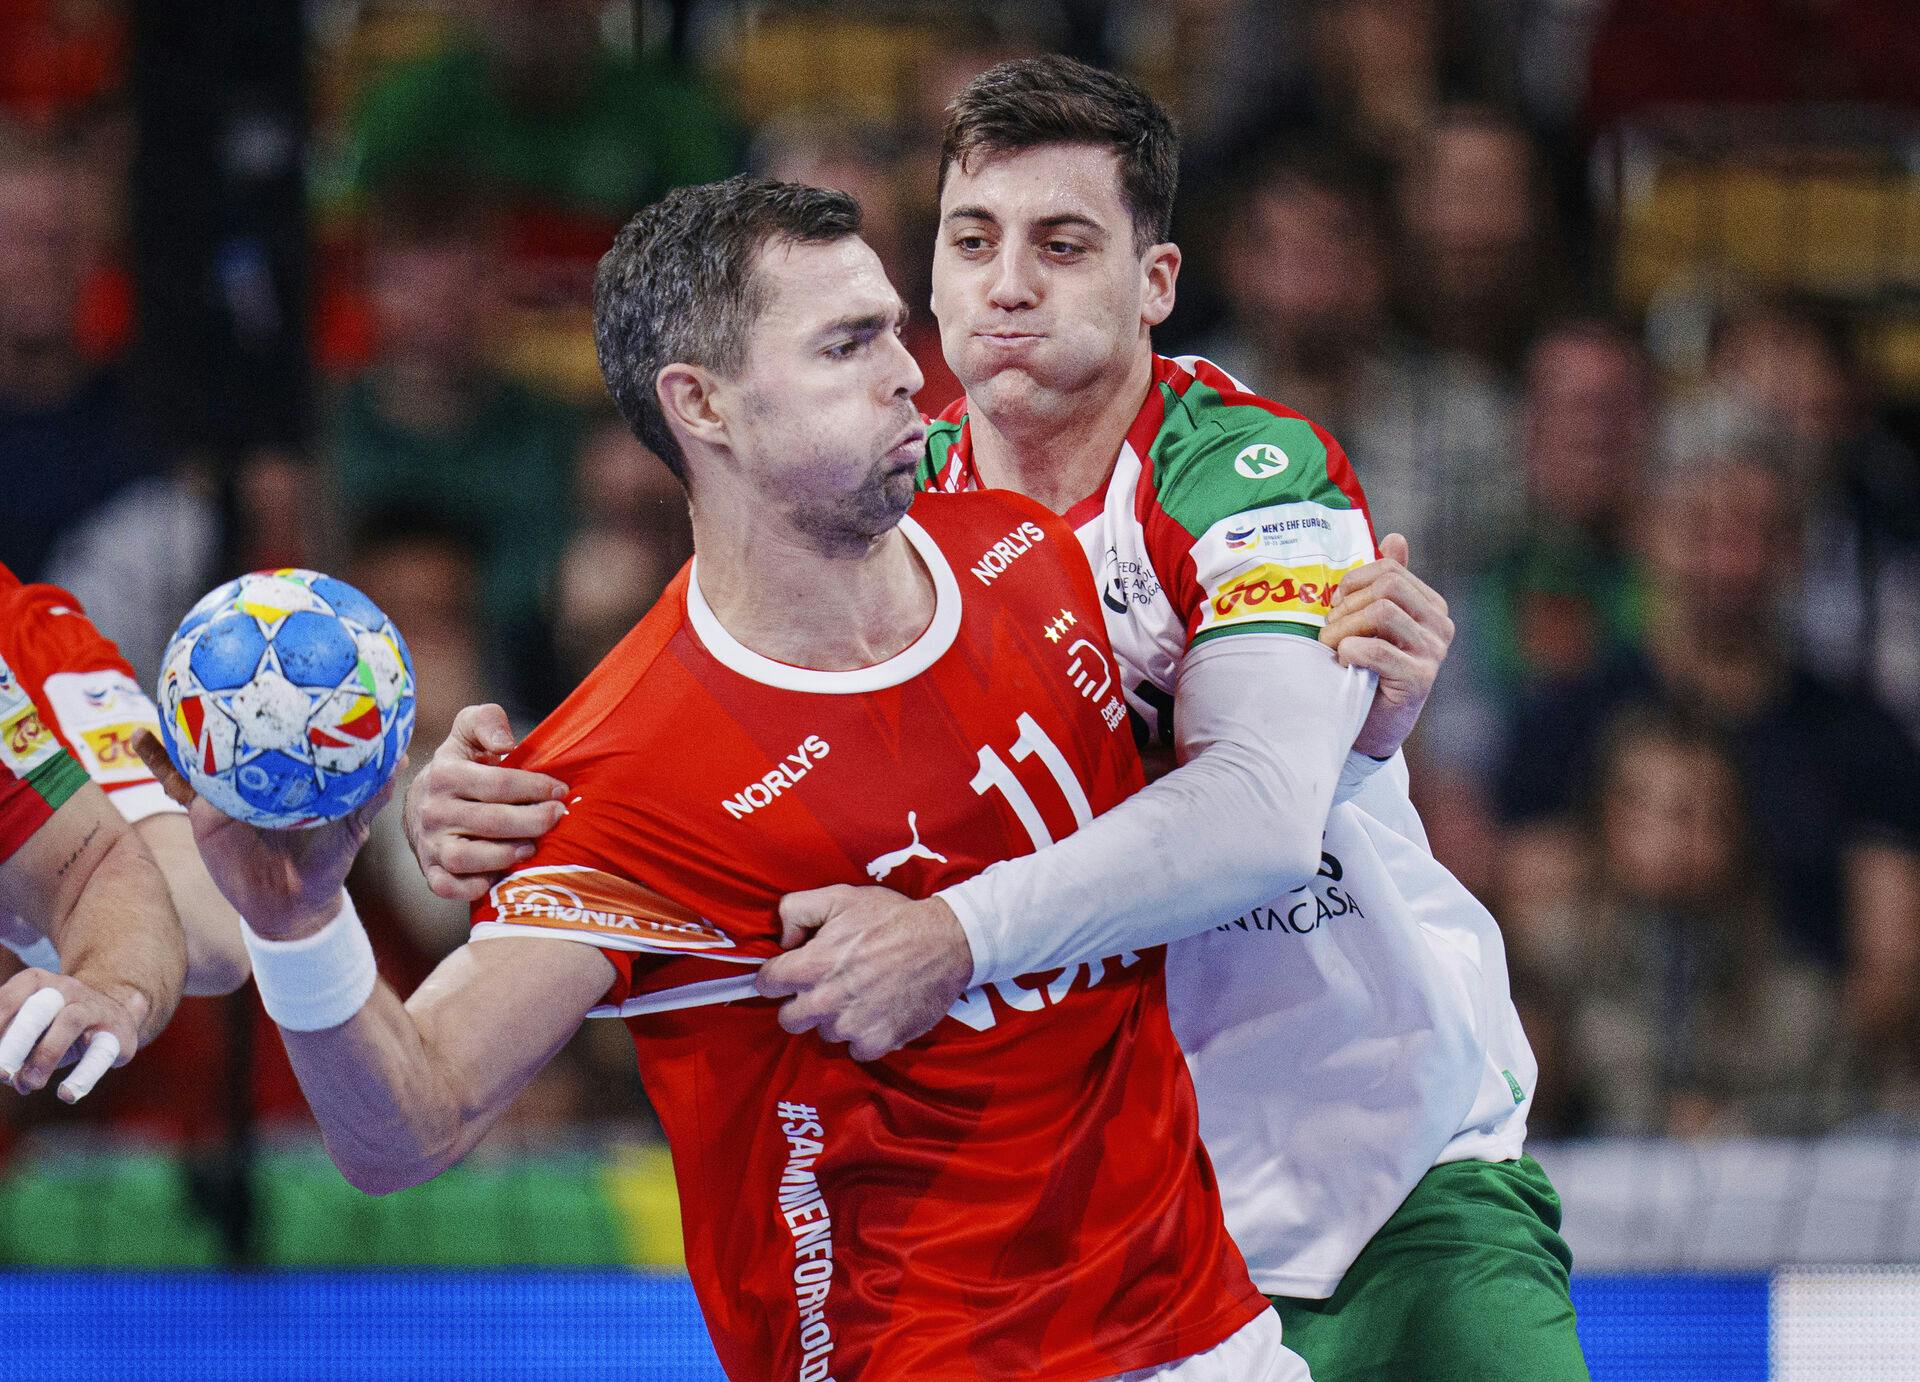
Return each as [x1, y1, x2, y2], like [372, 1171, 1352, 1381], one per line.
[474, 493, 1265, 1382]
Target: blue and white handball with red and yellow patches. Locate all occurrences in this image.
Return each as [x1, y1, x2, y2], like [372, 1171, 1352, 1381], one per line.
[159, 568, 413, 829]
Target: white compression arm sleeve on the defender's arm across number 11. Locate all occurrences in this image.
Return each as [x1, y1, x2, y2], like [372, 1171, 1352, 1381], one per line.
[939, 633, 1375, 985]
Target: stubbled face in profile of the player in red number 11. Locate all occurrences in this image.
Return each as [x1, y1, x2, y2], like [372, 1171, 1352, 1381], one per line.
[730, 236, 925, 543]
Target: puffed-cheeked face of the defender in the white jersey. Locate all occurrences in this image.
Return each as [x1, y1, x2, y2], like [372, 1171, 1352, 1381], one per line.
[933, 144, 1173, 415]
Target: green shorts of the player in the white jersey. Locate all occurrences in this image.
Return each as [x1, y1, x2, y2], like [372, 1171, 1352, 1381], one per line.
[1273, 1157, 1588, 1382]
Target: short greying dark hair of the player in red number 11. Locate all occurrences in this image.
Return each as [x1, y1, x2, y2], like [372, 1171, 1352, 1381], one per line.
[593, 177, 860, 482]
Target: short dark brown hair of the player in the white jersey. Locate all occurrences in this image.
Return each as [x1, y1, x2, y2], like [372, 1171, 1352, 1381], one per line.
[941, 54, 1181, 253]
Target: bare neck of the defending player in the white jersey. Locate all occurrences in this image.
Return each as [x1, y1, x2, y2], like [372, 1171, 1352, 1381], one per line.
[970, 344, 1154, 512]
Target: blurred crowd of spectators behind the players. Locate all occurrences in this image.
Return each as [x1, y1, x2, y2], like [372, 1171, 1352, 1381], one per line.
[0, 0, 1920, 1232]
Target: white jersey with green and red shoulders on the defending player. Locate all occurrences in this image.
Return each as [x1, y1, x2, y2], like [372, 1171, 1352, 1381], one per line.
[924, 357, 1536, 1298]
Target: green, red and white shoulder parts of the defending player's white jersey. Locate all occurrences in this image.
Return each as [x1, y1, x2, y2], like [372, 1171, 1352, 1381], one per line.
[920, 355, 1379, 643]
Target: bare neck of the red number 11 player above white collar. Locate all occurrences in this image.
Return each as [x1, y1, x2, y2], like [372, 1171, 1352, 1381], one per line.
[693, 495, 933, 672]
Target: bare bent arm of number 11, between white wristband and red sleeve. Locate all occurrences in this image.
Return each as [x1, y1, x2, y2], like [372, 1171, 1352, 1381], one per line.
[280, 939, 614, 1194]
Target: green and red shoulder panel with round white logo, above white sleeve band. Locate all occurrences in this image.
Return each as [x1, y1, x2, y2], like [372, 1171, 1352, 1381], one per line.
[1142, 355, 1365, 534]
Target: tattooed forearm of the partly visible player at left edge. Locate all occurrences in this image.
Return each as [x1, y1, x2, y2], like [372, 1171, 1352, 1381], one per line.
[48, 829, 186, 1044]
